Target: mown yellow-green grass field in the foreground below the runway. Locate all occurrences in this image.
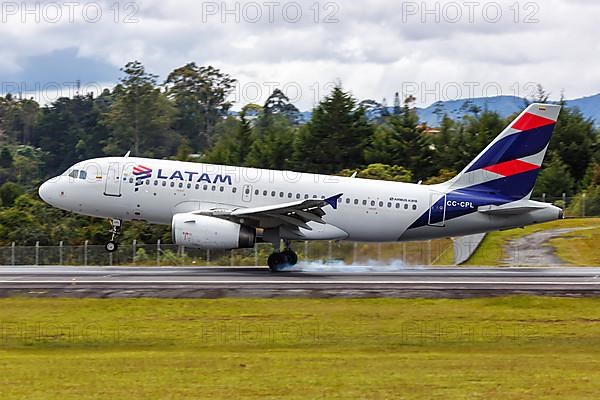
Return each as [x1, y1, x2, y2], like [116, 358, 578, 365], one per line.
[0, 297, 600, 399]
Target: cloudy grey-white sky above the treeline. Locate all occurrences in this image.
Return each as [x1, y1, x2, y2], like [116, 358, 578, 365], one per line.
[0, 0, 600, 110]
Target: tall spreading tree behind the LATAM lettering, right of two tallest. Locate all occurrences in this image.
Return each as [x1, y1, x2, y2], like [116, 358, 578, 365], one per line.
[165, 62, 236, 150]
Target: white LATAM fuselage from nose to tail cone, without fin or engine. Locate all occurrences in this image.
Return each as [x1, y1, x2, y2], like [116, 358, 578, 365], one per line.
[40, 157, 560, 242]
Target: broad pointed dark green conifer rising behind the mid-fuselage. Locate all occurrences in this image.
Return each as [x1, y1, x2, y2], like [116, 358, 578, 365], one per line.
[294, 85, 373, 174]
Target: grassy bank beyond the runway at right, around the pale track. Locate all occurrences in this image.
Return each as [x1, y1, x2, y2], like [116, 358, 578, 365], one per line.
[463, 218, 600, 266]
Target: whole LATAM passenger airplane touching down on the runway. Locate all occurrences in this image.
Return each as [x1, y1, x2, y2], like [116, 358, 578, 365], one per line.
[39, 104, 563, 272]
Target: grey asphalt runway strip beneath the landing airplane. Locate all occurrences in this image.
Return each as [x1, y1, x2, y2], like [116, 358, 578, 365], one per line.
[0, 266, 600, 298]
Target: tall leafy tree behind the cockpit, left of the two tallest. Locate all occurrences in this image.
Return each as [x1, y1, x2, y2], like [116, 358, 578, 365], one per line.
[103, 61, 175, 158]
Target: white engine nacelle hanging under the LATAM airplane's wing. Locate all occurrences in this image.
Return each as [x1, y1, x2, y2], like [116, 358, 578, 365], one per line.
[171, 213, 256, 250]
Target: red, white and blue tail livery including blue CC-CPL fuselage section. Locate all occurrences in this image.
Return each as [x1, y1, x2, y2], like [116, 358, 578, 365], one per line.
[409, 104, 560, 233]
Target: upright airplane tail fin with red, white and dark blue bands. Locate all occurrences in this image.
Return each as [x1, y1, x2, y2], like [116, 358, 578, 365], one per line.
[448, 103, 561, 200]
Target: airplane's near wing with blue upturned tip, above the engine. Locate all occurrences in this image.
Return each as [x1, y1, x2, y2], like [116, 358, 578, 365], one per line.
[194, 194, 342, 231]
